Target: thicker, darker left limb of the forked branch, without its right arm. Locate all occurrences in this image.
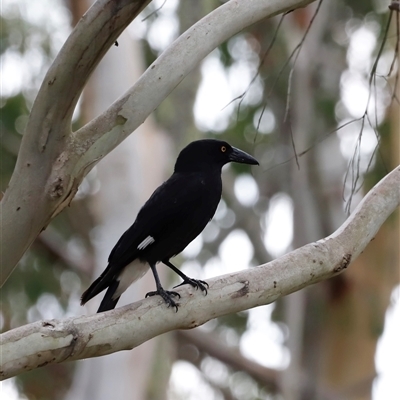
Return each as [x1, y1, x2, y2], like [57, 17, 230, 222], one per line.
[0, 0, 150, 287]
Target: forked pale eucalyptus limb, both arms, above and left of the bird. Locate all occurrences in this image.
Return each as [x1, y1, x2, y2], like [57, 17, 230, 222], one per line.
[0, 0, 315, 286]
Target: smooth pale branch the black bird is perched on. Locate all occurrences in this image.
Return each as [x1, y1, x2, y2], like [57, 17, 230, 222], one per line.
[0, 167, 400, 379]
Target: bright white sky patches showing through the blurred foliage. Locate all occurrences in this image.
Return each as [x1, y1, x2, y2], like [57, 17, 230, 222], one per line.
[0, 0, 400, 400]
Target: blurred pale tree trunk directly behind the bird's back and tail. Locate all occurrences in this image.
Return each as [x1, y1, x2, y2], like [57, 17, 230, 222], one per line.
[67, 25, 170, 400]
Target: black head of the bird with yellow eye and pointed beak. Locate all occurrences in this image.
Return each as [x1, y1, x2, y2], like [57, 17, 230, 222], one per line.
[175, 139, 259, 172]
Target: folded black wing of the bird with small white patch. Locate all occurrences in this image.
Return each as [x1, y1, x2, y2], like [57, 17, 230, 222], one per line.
[108, 173, 221, 266]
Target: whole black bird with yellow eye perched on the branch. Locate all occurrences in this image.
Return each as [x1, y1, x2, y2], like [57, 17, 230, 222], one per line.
[81, 139, 258, 312]
